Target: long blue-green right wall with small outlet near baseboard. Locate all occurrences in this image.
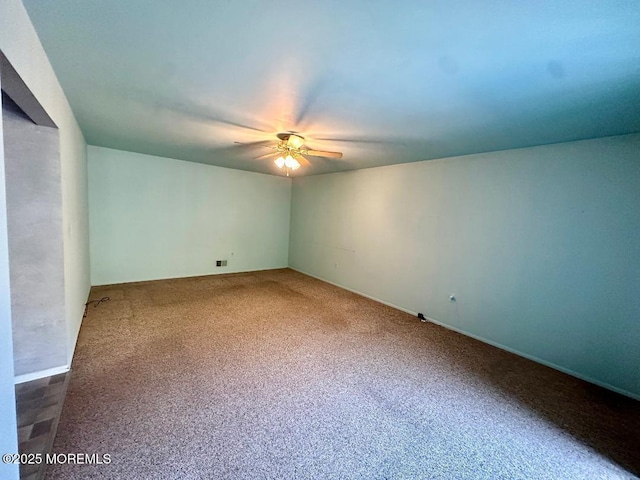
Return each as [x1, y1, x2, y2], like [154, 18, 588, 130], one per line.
[289, 134, 640, 397]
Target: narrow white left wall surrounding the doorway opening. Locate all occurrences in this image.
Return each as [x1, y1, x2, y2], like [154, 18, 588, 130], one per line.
[0, 0, 90, 376]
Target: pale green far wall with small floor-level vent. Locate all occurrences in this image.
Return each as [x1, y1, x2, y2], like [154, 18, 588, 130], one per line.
[89, 147, 291, 285]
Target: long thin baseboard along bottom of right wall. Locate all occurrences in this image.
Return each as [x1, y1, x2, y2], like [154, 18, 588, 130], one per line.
[289, 267, 640, 400]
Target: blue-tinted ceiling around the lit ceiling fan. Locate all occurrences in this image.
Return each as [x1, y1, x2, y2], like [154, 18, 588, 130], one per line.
[24, 0, 640, 175]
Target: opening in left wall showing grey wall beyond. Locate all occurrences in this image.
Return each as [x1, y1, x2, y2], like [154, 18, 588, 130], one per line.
[0, 51, 67, 380]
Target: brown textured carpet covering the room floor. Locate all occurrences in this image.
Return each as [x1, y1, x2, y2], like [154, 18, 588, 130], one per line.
[47, 270, 640, 479]
